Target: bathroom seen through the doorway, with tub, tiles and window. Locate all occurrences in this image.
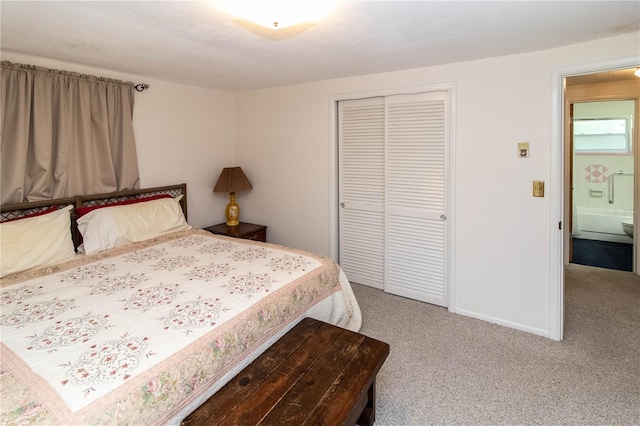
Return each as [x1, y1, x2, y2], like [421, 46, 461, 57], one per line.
[565, 70, 638, 271]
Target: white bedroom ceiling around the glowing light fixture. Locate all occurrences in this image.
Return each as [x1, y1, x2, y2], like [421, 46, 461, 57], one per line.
[0, 0, 640, 92]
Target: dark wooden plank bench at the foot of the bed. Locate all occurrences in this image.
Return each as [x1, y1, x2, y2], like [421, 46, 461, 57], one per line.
[182, 318, 389, 426]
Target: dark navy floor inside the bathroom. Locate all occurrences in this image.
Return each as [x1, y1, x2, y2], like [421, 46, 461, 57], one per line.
[572, 238, 633, 271]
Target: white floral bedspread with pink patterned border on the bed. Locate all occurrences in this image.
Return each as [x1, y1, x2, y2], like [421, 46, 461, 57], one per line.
[0, 231, 356, 424]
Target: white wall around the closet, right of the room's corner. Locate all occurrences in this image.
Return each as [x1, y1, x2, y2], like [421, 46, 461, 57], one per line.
[235, 33, 640, 335]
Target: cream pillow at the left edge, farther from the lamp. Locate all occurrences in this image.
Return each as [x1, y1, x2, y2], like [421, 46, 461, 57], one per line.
[0, 206, 76, 277]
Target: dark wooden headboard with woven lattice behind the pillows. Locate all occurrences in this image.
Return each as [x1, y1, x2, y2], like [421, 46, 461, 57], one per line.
[0, 183, 187, 248]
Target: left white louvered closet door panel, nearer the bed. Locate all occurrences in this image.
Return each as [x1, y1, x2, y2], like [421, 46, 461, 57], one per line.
[338, 98, 385, 289]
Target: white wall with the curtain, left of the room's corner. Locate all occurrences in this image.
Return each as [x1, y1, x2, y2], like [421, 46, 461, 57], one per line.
[1, 51, 234, 227]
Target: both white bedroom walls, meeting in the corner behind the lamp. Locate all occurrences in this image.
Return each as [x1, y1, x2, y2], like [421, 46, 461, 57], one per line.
[2, 33, 640, 335]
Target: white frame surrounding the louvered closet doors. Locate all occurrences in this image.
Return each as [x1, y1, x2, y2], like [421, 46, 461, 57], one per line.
[329, 82, 456, 313]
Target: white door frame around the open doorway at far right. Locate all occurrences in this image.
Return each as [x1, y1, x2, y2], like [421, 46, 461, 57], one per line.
[549, 56, 639, 340]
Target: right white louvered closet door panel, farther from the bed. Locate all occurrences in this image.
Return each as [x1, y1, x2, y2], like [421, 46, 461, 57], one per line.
[384, 92, 448, 306]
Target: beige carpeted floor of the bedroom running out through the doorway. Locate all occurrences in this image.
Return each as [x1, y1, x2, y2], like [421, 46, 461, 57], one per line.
[353, 265, 640, 426]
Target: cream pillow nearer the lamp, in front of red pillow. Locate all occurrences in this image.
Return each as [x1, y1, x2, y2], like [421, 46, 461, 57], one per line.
[78, 196, 191, 254]
